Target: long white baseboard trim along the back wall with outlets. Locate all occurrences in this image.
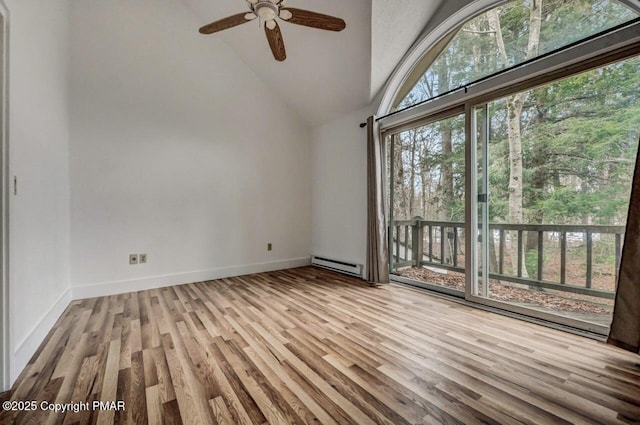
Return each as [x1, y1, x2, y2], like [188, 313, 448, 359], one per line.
[71, 257, 311, 300]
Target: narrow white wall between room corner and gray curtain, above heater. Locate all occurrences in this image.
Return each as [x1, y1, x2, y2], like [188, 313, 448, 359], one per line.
[312, 107, 374, 264]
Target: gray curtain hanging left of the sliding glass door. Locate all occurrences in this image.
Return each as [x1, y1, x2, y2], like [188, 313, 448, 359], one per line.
[367, 117, 389, 283]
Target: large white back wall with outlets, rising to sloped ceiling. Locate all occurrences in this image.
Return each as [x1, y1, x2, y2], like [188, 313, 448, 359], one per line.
[70, 0, 311, 298]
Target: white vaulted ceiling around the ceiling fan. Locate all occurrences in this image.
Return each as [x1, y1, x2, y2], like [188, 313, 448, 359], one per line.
[182, 0, 442, 126]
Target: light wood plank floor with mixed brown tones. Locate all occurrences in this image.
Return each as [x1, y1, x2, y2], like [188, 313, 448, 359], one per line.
[0, 268, 640, 425]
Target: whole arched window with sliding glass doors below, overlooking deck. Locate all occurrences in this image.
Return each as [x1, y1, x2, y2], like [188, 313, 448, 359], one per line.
[378, 0, 640, 334]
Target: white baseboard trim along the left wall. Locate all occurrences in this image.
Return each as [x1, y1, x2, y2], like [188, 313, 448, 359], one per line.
[10, 288, 71, 385]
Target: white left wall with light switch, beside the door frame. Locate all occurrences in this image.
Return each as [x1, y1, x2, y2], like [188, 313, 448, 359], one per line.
[6, 0, 70, 382]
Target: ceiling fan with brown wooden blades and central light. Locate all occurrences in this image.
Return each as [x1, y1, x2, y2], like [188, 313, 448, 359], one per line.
[200, 0, 347, 61]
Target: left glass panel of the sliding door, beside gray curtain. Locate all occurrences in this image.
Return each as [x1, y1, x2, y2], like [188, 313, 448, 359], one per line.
[386, 114, 465, 296]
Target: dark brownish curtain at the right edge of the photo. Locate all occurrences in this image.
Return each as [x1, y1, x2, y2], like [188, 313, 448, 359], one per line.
[608, 137, 640, 353]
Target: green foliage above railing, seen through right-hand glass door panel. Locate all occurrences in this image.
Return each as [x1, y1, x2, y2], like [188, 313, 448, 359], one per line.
[489, 58, 640, 225]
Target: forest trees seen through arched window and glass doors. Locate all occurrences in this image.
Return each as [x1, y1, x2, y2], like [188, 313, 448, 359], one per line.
[388, 0, 640, 288]
